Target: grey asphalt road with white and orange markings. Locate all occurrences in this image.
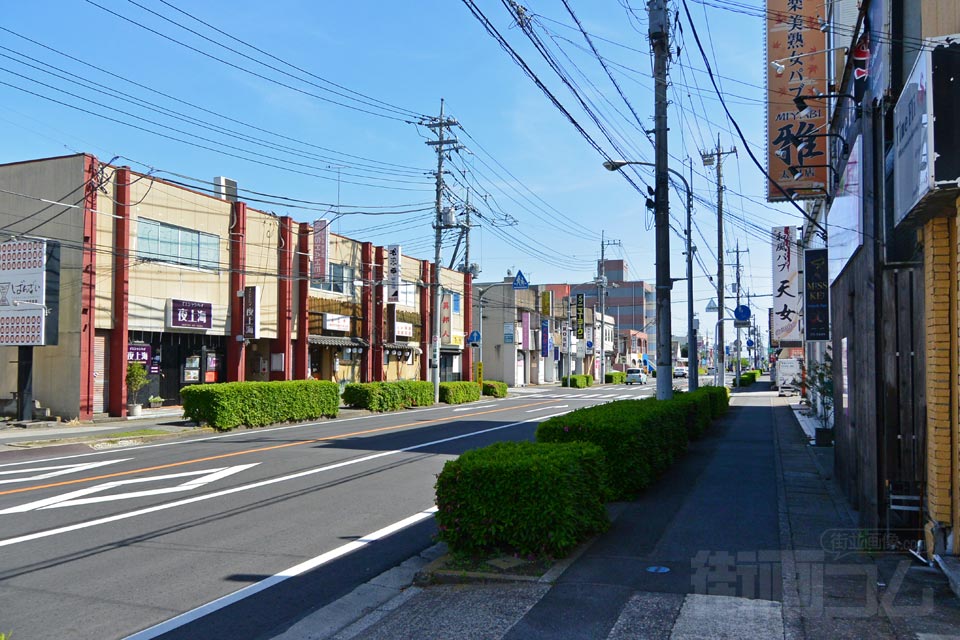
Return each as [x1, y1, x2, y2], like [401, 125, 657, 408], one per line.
[0, 383, 653, 639]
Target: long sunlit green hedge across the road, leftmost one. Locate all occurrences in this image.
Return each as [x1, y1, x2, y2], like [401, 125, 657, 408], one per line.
[180, 380, 340, 431]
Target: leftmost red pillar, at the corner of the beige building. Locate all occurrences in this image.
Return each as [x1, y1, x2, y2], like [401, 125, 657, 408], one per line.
[79, 155, 99, 420]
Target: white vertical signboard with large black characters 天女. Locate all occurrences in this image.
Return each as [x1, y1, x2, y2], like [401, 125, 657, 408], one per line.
[771, 227, 803, 347]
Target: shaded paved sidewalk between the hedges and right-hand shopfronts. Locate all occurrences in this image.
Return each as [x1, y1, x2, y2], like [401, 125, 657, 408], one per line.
[276, 383, 960, 640]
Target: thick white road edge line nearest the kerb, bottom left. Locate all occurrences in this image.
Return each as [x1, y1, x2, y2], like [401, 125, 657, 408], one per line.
[126, 507, 437, 640]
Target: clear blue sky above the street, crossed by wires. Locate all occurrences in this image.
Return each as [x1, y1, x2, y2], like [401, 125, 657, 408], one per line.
[0, 0, 799, 334]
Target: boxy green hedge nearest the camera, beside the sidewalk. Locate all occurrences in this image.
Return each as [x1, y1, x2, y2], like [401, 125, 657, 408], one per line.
[436, 442, 609, 557]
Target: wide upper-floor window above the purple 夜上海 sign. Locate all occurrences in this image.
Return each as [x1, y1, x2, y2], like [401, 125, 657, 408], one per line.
[137, 218, 220, 269]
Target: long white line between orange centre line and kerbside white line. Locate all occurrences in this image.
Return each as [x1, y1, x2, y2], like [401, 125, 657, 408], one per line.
[0, 411, 567, 547]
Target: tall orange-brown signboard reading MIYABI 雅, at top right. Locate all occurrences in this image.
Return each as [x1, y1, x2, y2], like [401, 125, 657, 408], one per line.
[765, 0, 830, 202]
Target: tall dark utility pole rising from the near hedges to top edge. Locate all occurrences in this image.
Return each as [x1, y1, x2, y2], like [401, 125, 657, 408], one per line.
[647, 0, 673, 400]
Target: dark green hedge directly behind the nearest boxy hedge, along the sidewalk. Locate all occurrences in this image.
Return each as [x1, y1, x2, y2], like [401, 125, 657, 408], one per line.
[537, 398, 688, 499]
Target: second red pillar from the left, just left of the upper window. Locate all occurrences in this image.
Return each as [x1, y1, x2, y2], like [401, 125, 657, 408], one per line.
[107, 167, 130, 416]
